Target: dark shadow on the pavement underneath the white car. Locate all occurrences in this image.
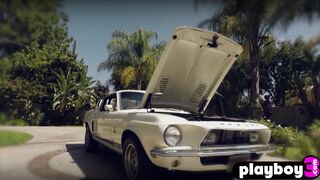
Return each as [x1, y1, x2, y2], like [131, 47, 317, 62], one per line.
[66, 144, 233, 180]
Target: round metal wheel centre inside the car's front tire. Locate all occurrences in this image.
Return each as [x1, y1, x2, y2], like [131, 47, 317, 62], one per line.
[125, 144, 139, 179]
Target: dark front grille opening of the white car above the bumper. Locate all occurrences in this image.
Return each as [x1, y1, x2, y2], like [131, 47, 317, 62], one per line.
[200, 130, 259, 147]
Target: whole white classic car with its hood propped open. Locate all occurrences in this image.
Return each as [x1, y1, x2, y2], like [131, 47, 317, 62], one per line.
[84, 27, 273, 179]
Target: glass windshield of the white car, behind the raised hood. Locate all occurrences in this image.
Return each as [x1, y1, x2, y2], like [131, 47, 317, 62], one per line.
[120, 92, 144, 109]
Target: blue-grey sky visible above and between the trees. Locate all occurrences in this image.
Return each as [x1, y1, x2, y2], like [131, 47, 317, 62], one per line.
[62, 0, 320, 87]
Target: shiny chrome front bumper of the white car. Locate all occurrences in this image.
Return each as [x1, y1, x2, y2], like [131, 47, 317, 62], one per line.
[150, 145, 275, 157]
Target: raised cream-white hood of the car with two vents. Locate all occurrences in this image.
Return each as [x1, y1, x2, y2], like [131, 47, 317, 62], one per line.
[140, 27, 242, 113]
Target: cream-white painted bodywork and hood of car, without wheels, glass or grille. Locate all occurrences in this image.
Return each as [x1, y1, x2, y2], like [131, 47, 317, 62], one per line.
[84, 27, 271, 171]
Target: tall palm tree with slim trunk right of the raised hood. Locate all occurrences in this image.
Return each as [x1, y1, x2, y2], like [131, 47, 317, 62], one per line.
[199, 0, 319, 113]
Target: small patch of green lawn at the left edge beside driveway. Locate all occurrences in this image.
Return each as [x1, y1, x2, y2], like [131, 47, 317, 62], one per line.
[0, 130, 33, 147]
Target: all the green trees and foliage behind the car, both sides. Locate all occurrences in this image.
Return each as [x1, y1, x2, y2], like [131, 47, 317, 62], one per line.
[0, 0, 320, 125]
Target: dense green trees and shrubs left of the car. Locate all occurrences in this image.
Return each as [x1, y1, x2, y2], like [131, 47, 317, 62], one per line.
[0, 0, 97, 125]
